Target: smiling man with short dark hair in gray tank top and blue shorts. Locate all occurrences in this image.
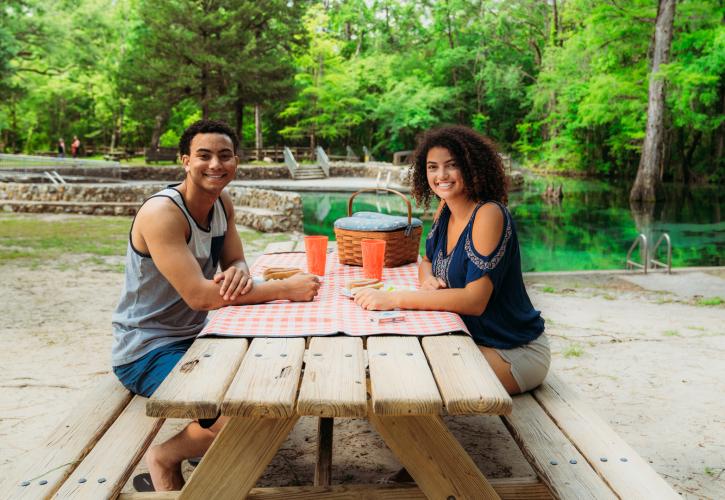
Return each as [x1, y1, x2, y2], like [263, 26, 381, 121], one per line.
[112, 120, 320, 491]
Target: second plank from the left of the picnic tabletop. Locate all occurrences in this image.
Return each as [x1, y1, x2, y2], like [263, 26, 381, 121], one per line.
[222, 338, 305, 417]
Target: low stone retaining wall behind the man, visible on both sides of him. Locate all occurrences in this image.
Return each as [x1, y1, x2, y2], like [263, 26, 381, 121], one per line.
[0, 182, 302, 232]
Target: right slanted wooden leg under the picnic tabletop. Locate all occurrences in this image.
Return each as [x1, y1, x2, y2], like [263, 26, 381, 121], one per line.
[368, 411, 499, 499]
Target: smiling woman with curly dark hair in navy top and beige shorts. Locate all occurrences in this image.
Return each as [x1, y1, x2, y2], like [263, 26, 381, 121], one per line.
[355, 126, 550, 394]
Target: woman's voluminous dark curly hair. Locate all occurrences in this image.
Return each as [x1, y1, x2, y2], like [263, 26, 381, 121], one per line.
[410, 125, 508, 208]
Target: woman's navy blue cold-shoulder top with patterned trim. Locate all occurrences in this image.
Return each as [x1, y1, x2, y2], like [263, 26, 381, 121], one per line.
[425, 202, 544, 349]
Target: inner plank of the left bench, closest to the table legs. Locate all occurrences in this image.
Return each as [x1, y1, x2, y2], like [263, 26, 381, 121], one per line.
[54, 396, 164, 500]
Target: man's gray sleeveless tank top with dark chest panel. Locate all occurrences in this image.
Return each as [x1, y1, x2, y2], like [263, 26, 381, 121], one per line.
[111, 187, 227, 366]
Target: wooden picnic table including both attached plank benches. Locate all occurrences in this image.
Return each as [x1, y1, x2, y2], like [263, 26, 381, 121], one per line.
[0, 243, 679, 500]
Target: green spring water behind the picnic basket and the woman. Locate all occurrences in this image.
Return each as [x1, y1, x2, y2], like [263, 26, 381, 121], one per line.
[302, 177, 725, 271]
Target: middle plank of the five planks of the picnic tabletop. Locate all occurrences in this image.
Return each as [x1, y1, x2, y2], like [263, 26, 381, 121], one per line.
[297, 337, 367, 417]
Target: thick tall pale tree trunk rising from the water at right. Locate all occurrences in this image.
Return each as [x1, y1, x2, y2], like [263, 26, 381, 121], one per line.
[629, 0, 675, 202]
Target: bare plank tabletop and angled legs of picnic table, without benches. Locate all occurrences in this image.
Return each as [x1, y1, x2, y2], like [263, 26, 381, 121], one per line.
[146, 241, 512, 498]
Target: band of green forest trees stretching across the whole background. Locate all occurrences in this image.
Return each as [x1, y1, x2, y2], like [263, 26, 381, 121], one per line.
[0, 0, 725, 183]
